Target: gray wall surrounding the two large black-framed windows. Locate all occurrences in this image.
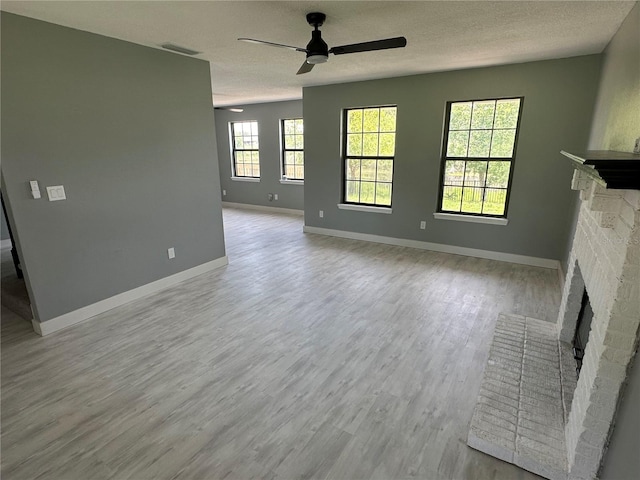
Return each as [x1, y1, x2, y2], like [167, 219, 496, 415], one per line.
[303, 55, 600, 260]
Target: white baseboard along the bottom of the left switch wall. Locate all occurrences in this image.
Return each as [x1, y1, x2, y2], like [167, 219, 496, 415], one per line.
[31, 255, 229, 336]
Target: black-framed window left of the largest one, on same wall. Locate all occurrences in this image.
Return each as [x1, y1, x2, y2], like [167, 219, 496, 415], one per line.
[343, 106, 397, 207]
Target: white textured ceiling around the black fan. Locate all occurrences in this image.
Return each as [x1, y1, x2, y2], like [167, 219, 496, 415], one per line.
[1, 0, 634, 106]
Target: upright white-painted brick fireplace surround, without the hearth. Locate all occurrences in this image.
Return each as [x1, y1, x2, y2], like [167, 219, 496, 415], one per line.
[557, 170, 640, 479]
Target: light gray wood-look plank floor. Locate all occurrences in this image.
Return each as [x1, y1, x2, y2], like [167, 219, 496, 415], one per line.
[1, 209, 560, 480]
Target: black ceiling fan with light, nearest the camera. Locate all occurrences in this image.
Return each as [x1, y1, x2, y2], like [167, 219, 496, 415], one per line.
[238, 12, 407, 75]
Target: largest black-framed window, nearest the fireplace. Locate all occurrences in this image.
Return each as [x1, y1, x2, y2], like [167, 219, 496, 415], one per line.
[438, 97, 522, 217]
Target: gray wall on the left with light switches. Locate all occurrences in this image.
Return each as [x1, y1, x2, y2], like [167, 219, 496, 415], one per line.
[1, 12, 225, 321]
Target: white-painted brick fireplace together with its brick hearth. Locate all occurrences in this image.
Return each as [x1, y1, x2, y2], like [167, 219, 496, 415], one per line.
[467, 166, 640, 480]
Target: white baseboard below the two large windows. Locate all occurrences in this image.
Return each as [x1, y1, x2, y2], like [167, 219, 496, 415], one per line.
[302, 225, 560, 269]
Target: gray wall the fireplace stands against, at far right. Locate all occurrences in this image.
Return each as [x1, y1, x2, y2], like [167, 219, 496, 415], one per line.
[589, 5, 640, 480]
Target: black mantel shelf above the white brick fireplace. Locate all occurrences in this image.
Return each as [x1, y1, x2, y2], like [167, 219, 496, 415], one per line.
[560, 150, 640, 190]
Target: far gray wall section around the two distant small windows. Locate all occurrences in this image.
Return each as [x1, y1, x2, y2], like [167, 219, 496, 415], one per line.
[216, 100, 304, 210]
